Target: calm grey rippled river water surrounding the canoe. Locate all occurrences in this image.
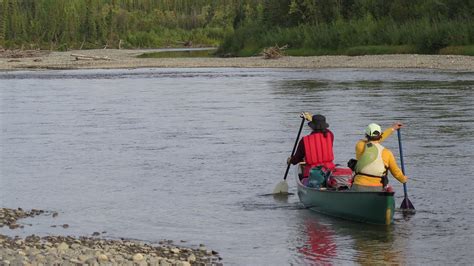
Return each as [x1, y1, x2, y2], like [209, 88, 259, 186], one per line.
[0, 69, 474, 265]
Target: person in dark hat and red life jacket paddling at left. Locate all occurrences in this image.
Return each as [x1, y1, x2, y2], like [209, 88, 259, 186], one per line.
[288, 112, 335, 177]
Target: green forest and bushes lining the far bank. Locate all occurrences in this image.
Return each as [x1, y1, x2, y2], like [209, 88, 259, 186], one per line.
[0, 0, 474, 56]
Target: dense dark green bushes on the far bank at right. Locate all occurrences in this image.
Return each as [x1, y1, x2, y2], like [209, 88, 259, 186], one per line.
[218, 15, 474, 55]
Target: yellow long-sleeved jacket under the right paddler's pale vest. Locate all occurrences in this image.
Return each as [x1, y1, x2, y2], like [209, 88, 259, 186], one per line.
[354, 128, 407, 186]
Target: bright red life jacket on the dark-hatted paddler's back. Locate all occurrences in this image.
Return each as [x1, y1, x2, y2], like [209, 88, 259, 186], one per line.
[303, 130, 335, 176]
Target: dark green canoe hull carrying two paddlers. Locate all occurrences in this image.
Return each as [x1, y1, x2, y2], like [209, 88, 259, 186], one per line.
[296, 177, 395, 225]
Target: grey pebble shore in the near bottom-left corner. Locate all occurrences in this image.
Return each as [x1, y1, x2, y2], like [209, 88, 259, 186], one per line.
[0, 208, 222, 266]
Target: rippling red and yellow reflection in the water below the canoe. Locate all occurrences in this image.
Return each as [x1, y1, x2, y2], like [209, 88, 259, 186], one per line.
[297, 213, 410, 265]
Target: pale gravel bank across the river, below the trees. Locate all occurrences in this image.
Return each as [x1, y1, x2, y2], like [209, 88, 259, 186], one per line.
[0, 49, 474, 72]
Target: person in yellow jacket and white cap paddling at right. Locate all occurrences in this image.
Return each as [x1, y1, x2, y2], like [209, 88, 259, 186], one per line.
[351, 123, 408, 191]
